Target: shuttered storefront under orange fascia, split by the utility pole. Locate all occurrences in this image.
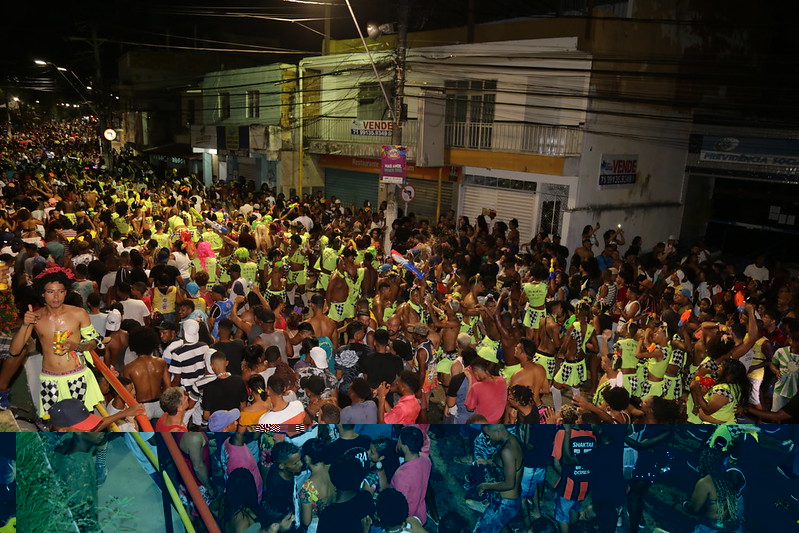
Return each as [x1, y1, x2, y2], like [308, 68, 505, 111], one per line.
[319, 155, 460, 223]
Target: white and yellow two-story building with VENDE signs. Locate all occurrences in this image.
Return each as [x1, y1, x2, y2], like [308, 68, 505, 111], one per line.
[300, 31, 688, 248]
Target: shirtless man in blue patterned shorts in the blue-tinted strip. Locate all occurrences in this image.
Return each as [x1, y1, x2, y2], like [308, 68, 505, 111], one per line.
[474, 424, 524, 531]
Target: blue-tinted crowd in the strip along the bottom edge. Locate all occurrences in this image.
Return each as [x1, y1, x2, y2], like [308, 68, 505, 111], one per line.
[31, 423, 799, 533]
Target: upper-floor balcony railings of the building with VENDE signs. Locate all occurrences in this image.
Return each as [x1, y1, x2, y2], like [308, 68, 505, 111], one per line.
[305, 118, 583, 157]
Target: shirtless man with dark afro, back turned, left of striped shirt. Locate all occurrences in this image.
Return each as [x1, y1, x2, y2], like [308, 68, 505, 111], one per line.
[122, 327, 170, 419]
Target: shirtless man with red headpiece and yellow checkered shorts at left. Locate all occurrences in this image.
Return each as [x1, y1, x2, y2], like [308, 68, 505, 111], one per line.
[9, 266, 103, 418]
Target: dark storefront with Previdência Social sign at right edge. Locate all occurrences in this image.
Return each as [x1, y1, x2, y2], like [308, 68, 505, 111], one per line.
[681, 132, 799, 261]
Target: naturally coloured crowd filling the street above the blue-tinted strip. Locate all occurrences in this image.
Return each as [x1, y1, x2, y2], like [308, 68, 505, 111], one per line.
[0, 118, 799, 431]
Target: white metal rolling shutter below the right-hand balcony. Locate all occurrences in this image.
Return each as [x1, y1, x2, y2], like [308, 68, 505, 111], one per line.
[461, 185, 536, 244]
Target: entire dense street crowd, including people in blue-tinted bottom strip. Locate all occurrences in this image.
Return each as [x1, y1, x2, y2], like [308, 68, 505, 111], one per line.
[0, 122, 799, 532]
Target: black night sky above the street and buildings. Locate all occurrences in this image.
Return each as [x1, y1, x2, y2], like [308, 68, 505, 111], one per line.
[0, 0, 799, 118]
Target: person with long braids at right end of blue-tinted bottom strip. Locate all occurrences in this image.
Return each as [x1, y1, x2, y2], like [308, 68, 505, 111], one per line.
[683, 448, 745, 533]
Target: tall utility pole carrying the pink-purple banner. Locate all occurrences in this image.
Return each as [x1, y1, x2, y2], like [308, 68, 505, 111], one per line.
[383, 0, 408, 255]
